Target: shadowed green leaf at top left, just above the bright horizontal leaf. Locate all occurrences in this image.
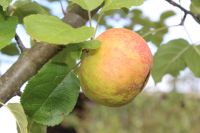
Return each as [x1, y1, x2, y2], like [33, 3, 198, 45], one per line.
[12, 0, 49, 23]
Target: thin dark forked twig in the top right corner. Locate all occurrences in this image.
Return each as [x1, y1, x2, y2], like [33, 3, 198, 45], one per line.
[165, 0, 200, 24]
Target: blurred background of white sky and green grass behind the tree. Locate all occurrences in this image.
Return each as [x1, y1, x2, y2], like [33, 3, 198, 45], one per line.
[0, 0, 200, 133]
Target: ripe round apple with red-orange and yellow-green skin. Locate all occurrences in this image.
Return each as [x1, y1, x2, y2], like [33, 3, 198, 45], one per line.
[79, 28, 152, 107]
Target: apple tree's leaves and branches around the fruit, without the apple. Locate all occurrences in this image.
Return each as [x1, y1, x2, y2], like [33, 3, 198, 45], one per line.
[0, 0, 200, 133]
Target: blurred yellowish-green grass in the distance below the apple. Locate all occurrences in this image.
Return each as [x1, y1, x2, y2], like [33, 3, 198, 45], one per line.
[64, 92, 200, 133]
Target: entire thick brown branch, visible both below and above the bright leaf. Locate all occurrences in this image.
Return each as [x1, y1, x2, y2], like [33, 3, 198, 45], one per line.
[0, 5, 96, 103]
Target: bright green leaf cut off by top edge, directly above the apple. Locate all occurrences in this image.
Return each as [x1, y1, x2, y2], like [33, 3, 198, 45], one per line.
[102, 0, 144, 12]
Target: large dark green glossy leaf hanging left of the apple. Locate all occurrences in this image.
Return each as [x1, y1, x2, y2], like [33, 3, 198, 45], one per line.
[21, 63, 80, 126]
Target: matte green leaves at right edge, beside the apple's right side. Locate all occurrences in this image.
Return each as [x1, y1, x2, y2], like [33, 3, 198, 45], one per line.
[152, 39, 200, 82]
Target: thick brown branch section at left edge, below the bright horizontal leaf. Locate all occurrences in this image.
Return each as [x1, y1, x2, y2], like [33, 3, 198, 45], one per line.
[0, 43, 59, 103]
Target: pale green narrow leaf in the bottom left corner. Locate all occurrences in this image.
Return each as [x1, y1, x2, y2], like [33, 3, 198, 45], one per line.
[6, 103, 28, 133]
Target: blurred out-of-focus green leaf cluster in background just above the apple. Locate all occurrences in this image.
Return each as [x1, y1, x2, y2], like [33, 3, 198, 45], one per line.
[100, 9, 175, 47]
